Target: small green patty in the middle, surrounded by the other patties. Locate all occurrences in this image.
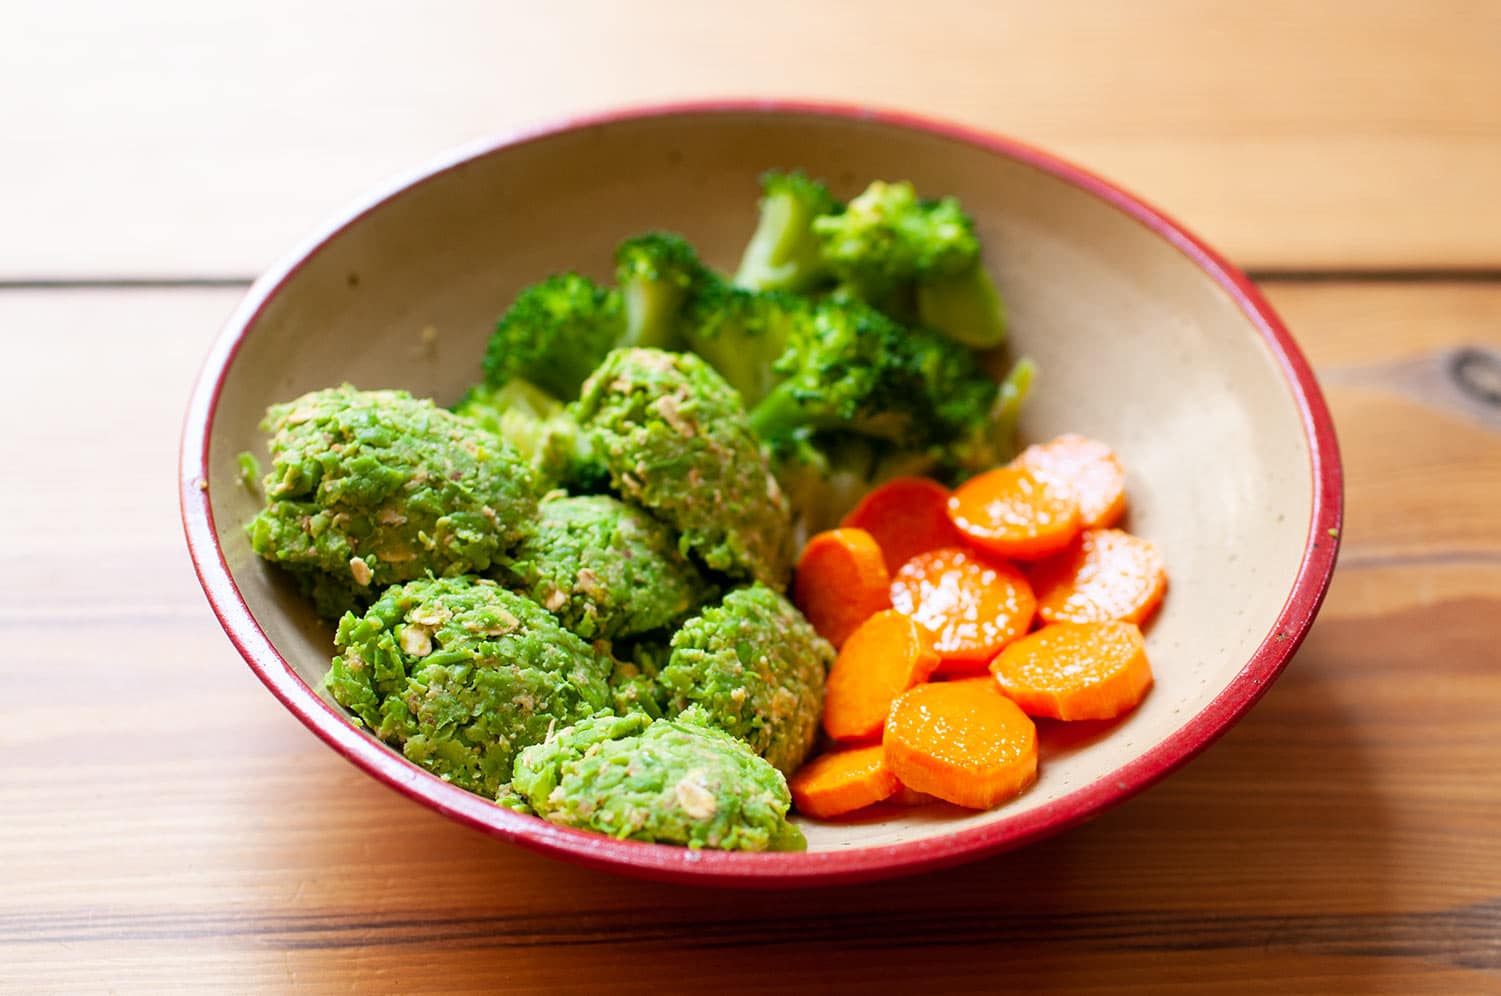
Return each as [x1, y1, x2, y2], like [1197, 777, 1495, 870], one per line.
[506, 495, 711, 639]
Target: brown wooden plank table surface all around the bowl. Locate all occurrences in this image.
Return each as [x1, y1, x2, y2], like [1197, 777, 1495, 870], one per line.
[0, 0, 1501, 993]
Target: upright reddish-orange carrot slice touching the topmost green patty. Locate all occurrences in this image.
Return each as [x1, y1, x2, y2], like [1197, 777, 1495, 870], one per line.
[793, 530, 892, 647]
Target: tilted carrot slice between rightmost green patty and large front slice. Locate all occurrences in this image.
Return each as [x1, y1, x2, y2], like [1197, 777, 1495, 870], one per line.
[824, 609, 938, 740]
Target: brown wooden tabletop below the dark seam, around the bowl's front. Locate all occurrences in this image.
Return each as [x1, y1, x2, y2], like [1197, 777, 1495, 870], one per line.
[0, 284, 1501, 993]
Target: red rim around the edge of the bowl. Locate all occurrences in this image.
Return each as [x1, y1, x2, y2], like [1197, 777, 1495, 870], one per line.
[179, 99, 1343, 888]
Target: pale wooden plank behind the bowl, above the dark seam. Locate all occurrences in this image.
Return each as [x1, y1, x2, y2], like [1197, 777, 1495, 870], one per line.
[0, 0, 1501, 279]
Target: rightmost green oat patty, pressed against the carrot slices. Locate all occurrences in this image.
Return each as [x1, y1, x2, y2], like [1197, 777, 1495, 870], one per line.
[657, 585, 835, 774]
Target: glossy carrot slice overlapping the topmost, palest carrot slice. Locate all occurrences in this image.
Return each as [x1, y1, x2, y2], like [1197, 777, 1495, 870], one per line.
[949, 467, 1079, 560]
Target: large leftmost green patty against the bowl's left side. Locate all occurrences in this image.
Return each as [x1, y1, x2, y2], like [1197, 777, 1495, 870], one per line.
[246, 384, 537, 618]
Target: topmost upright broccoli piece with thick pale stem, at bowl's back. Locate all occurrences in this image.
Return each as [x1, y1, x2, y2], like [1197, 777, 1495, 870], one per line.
[735, 170, 839, 291]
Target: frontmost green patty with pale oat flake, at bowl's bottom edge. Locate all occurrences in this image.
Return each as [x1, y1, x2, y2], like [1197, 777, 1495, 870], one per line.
[512, 711, 806, 851]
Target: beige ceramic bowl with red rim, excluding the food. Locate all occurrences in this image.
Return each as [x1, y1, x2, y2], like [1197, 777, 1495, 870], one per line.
[180, 102, 1340, 887]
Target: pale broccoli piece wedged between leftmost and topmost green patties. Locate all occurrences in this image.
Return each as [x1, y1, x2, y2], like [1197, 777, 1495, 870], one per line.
[453, 378, 609, 494]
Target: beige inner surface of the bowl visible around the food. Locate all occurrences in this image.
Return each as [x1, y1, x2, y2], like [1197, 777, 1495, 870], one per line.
[209, 110, 1313, 851]
